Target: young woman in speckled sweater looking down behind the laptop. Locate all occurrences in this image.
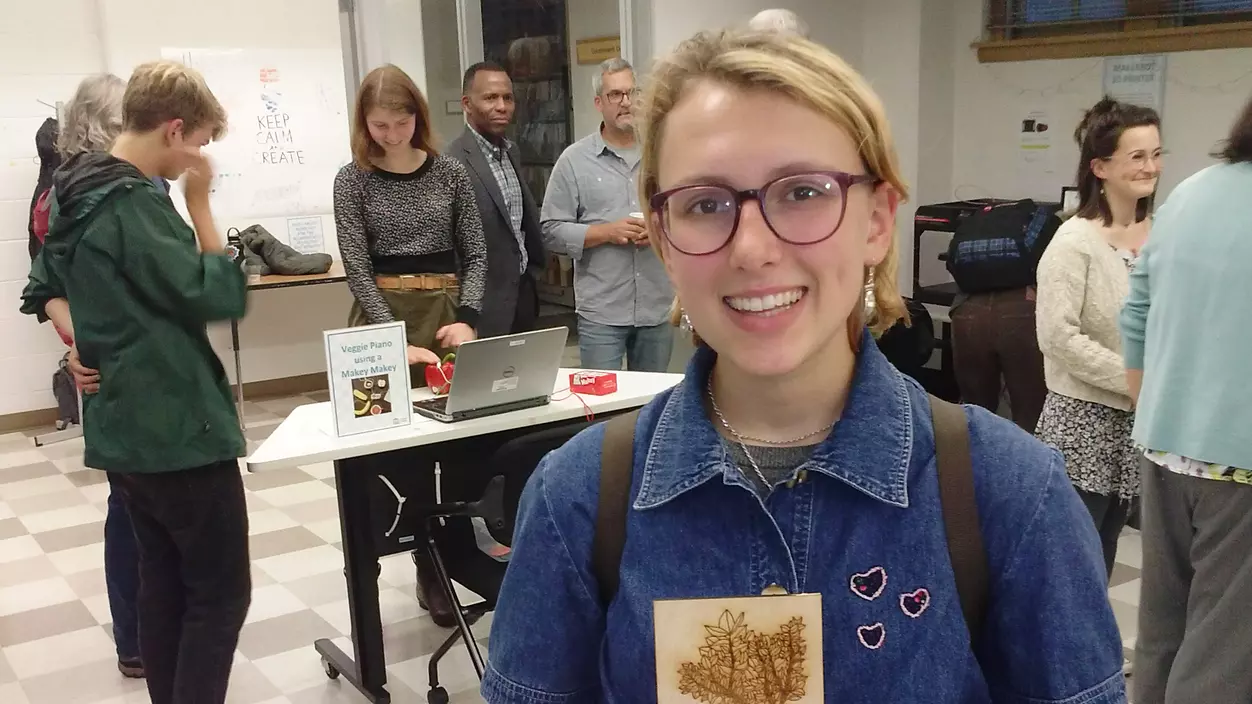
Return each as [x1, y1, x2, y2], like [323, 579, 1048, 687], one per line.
[334, 65, 487, 626]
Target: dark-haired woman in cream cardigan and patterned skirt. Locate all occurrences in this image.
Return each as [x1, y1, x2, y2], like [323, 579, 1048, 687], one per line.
[1037, 98, 1161, 575]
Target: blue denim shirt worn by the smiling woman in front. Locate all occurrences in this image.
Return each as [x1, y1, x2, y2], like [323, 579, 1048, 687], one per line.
[482, 336, 1126, 704]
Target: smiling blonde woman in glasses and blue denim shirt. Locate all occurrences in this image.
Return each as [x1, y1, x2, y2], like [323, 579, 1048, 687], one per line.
[483, 33, 1126, 704]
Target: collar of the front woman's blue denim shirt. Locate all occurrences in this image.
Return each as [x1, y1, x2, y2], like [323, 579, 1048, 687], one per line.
[635, 331, 913, 511]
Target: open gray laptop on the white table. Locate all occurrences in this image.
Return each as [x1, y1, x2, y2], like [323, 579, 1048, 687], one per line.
[413, 327, 570, 423]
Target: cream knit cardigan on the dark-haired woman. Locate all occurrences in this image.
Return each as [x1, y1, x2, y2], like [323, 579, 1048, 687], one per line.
[1035, 217, 1132, 411]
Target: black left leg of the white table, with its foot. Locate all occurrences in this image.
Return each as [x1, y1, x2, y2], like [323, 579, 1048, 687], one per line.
[313, 457, 391, 704]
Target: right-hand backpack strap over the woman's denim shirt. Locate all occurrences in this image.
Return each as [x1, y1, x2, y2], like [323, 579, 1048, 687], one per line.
[930, 396, 990, 646]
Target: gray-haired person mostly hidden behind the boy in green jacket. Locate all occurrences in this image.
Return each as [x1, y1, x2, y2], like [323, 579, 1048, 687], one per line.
[36, 74, 144, 678]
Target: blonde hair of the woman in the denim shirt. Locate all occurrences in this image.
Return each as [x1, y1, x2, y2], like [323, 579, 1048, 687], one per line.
[637, 31, 909, 349]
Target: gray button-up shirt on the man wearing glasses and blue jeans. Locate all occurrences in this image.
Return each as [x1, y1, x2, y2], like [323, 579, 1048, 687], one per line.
[540, 130, 674, 327]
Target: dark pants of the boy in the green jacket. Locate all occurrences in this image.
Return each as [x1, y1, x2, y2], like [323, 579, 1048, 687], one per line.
[109, 460, 252, 704]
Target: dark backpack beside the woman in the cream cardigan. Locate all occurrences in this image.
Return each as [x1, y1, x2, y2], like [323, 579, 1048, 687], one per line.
[947, 199, 1060, 293]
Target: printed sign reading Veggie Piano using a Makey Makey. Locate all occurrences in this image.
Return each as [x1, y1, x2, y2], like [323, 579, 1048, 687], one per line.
[322, 322, 413, 437]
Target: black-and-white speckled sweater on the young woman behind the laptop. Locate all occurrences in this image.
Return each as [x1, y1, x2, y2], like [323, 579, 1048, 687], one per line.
[334, 157, 487, 327]
